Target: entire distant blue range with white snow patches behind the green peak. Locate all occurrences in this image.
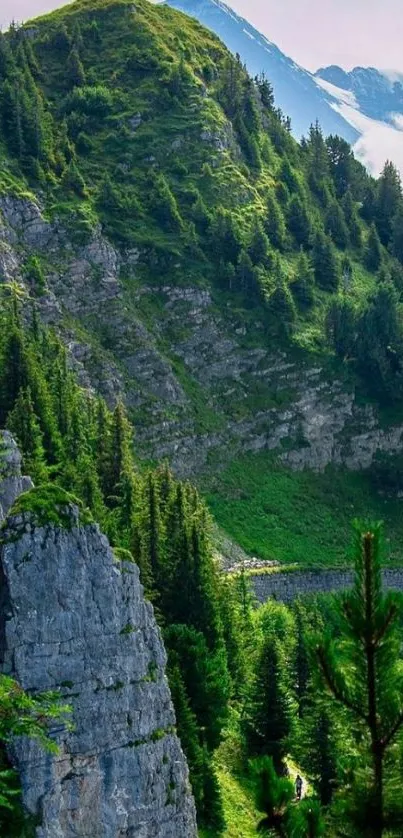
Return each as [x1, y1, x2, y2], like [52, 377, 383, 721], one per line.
[163, 0, 403, 174]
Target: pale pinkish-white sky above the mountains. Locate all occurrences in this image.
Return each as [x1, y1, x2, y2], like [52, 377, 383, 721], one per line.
[0, 0, 403, 71]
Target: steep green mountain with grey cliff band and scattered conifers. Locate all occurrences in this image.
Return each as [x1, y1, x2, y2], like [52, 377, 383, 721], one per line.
[0, 0, 403, 560]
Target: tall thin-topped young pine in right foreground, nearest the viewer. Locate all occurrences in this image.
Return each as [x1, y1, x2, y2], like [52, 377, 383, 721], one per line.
[316, 524, 403, 838]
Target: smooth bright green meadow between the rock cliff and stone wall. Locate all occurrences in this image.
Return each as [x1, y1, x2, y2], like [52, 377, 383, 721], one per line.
[206, 453, 403, 565]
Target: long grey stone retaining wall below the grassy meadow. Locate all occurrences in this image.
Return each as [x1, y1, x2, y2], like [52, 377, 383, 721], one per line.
[250, 569, 403, 602]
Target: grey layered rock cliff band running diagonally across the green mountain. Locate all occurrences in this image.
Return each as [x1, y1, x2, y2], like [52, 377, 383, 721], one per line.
[0, 196, 403, 478]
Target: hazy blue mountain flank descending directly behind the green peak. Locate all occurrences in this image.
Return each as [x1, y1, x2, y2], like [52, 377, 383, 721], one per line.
[169, 0, 359, 143]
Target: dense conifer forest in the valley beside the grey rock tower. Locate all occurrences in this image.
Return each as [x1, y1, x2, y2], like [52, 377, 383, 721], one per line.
[0, 290, 403, 838]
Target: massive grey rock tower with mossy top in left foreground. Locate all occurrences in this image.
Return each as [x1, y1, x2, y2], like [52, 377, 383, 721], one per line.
[0, 434, 197, 838]
